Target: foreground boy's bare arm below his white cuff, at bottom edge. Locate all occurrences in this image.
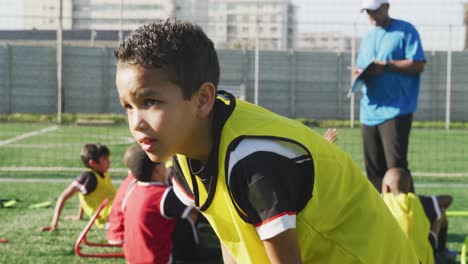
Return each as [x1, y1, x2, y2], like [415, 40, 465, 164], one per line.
[263, 229, 301, 264]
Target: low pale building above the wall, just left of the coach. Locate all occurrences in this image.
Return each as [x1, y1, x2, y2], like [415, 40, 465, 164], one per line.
[297, 32, 359, 52]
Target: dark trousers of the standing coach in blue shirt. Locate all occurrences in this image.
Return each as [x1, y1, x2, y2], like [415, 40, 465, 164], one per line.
[361, 114, 414, 192]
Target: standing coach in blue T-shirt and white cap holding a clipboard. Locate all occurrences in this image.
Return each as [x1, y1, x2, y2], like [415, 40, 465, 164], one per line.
[353, 0, 426, 191]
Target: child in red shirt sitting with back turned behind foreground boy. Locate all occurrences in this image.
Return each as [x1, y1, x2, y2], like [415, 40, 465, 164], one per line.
[122, 145, 197, 263]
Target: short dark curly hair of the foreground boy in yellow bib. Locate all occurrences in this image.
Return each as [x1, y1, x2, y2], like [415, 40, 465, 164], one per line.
[114, 18, 220, 100]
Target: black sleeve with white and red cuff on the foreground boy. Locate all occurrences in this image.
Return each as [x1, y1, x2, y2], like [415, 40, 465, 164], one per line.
[229, 141, 313, 240]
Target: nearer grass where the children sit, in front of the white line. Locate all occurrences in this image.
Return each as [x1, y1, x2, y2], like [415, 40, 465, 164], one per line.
[0, 183, 468, 263]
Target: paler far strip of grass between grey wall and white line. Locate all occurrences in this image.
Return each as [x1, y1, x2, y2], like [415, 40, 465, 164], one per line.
[0, 123, 468, 178]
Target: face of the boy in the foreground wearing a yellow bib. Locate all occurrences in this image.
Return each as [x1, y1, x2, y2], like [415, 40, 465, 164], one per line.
[116, 65, 197, 162]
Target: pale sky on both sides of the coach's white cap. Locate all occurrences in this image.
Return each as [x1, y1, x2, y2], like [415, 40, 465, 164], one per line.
[291, 0, 467, 51]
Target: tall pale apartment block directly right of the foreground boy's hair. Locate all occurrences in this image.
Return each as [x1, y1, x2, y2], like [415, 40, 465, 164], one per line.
[207, 0, 297, 50]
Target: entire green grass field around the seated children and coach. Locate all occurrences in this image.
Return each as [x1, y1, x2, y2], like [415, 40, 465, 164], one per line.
[0, 123, 468, 263]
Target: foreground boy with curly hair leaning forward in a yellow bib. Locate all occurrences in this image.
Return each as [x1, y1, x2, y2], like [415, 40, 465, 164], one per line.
[115, 19, 419, 263]
